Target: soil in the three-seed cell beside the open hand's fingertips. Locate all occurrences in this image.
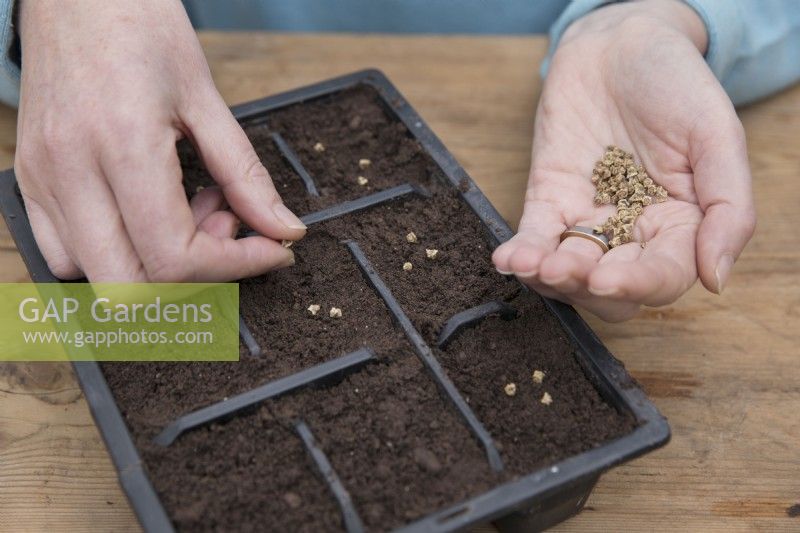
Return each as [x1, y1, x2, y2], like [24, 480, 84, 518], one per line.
[325, 193, 521, 345]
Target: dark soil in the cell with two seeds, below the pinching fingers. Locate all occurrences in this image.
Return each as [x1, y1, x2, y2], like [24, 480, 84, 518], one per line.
[103, 231, 406, 435]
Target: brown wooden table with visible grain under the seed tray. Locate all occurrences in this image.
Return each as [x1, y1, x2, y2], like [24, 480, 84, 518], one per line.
[0, 33, 800, 531]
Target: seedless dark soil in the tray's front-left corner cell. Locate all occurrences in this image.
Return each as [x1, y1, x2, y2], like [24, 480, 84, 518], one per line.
[137, 408, 341, 532]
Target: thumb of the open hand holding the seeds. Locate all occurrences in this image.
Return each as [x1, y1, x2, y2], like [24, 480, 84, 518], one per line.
[690, 114, 756, 294]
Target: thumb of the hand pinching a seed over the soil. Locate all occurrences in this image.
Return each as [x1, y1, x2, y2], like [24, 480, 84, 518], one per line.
[182, 87, 306, 240]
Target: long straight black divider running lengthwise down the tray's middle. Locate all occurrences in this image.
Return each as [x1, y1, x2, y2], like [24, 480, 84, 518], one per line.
[343, 240, 503, 472]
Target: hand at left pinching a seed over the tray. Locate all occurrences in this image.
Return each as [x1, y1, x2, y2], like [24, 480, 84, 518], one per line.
[14, 0, 305, 282]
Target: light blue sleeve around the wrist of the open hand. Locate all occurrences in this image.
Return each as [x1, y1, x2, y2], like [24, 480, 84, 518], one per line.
[542, 0, 800, 104]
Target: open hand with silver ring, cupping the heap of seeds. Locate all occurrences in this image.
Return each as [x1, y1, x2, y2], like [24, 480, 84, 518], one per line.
[494, 5, 755, 321]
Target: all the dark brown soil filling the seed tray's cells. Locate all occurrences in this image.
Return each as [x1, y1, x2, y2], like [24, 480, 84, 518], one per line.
[103, 86, 635, 531]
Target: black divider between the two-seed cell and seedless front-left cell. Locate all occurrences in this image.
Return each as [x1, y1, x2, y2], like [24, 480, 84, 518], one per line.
[153, 347, 376, 446]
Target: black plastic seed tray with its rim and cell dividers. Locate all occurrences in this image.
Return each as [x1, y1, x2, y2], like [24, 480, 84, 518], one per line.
[0, 70, 670, 532]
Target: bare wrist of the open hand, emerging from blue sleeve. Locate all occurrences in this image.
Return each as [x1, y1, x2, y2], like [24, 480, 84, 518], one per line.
[559, 0, 708, 55]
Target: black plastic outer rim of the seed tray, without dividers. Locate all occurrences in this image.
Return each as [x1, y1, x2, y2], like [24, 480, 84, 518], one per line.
[0, 69, 670, 532]
